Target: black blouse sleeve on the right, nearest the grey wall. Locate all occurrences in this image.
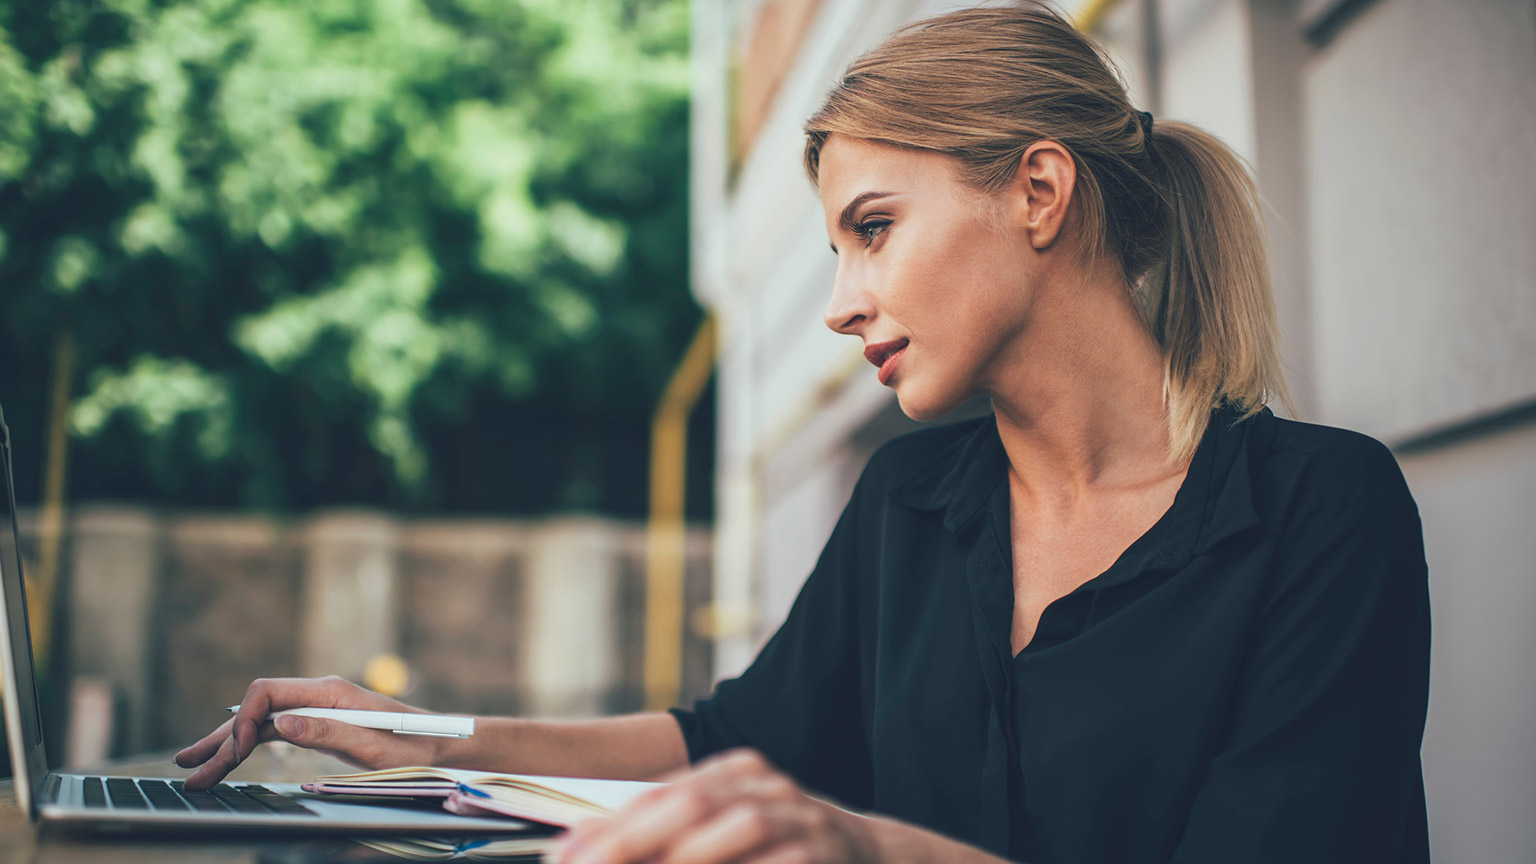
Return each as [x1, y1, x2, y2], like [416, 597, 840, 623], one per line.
[1174, 444, 1430, 862]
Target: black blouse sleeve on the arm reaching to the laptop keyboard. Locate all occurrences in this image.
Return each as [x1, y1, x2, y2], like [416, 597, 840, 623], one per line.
[671, 473, 871, 807]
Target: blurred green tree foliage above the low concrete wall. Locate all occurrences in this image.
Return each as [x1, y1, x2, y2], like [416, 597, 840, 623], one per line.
[0, 0, 708, 513]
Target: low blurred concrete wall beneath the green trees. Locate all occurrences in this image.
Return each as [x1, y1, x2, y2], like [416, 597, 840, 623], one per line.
[20, 506, 713, 759]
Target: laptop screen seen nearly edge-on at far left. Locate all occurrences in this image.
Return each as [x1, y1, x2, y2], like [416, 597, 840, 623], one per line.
[0, 410, 48, 816]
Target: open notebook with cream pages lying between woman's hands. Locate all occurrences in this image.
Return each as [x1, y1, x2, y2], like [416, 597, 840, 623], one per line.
[304, 767, 659, 829]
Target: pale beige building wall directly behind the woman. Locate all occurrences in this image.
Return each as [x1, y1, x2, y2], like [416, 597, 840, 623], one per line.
[694, 0, 1536, 864]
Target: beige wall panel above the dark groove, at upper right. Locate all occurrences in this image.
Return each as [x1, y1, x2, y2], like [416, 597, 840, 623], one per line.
[1303, 0, 1536, 441]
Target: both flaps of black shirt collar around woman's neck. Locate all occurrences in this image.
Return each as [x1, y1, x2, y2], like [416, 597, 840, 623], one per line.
[891, 406, 1275, 570]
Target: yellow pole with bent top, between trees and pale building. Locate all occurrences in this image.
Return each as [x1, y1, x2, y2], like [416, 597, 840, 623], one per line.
[645, 315, 716, 710]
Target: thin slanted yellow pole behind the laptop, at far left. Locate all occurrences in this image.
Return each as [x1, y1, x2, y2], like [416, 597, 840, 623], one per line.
[28, 331, 75, 667]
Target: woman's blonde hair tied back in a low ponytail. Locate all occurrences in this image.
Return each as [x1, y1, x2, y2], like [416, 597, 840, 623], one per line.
[805, 0, 1292, 461]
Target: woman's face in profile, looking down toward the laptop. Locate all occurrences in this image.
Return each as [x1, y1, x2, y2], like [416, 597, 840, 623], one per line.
[819, 134, 1035, 420]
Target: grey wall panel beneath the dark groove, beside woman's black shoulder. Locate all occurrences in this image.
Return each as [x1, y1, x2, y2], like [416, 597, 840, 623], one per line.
[1399, 420, 1536, 864]
